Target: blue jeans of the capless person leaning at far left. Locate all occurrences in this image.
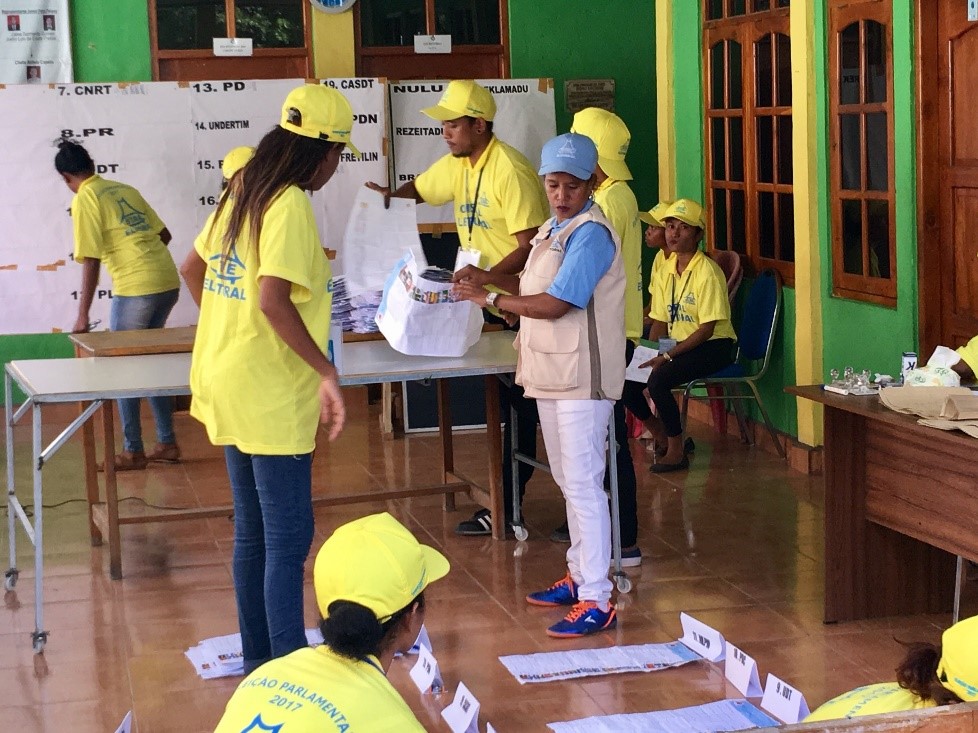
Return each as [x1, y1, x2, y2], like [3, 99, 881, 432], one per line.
[109, 290, 180, 453]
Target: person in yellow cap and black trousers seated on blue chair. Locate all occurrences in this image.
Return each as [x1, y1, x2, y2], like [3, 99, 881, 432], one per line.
[642, 199, 737, 473]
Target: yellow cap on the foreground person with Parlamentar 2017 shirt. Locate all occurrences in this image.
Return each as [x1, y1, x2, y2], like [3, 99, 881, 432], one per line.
[313, 512, 449, 622]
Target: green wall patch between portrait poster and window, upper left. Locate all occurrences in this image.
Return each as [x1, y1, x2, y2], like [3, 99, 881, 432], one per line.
[71, 0, 152, 82]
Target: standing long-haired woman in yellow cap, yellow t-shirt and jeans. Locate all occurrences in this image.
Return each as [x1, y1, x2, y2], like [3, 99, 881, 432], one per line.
[181, 84, 356, 673]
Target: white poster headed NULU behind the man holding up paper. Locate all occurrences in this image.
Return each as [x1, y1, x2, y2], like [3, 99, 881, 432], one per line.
[390, 79, 557, 229]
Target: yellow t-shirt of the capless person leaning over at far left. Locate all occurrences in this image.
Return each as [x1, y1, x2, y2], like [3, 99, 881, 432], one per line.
[71, 176, 180, 296]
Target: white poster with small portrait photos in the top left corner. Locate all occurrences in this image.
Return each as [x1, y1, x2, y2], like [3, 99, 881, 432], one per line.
[0, 0, 73, 84]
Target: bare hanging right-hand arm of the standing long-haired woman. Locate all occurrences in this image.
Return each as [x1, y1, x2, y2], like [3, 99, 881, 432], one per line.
[258, 275, 346, 440]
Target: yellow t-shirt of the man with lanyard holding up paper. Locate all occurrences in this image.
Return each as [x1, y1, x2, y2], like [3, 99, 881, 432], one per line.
[414, 137, 550, 267]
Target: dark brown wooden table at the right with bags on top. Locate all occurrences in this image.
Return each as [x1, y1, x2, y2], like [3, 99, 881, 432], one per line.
[785, 385, 960, 623]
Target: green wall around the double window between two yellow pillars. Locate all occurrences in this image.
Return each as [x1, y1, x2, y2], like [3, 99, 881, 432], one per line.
[671, 2, 798, 440]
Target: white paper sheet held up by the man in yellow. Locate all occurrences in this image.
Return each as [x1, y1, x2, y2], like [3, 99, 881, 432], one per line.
[340, 186, 425, 297]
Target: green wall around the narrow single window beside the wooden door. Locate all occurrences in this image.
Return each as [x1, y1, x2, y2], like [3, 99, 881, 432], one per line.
[816, 0, 918, 377]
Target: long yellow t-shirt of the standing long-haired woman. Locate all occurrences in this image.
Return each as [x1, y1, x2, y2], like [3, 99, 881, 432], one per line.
[190, 186, 333, 455]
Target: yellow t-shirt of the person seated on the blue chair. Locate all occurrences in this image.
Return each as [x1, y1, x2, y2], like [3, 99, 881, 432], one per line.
[651, 251, 737, 341]
